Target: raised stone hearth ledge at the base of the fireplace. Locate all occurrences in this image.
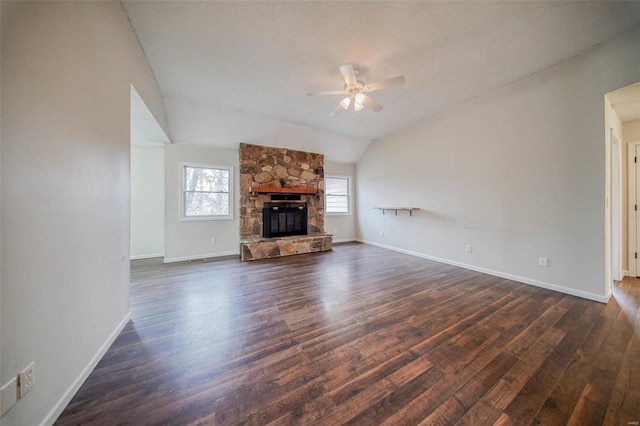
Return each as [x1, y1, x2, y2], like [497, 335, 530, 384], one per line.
[240, 234, 333, 260]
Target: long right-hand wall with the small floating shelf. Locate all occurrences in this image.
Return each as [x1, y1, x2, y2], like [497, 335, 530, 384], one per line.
[356, 29, 640, 301]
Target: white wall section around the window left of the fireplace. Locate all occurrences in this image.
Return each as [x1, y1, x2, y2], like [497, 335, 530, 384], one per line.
[164, 144, 240, 262]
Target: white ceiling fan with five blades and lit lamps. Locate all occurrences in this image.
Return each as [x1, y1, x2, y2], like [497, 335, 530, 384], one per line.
[308, 64, 404, 116]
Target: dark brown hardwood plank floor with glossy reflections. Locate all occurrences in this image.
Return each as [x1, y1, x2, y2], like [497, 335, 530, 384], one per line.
[56, 244, 640, 425]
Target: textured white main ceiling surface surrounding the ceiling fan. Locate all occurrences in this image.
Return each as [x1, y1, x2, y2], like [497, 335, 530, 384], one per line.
[123, 1, 640, 160]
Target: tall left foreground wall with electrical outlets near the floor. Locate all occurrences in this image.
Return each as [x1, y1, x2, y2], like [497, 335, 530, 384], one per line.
[1, 2, 167, 425]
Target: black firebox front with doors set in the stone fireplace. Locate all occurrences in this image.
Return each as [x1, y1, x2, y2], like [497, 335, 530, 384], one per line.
[262, 203, 307, 238]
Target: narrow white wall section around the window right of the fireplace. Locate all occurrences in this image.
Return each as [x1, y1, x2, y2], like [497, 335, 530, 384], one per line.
[324, 161, 358, 243]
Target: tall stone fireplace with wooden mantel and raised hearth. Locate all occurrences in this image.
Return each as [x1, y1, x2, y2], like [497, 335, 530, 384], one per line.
[239, 144, 332, 260]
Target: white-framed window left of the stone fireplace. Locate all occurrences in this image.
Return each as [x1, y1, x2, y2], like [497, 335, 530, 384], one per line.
[182, 163, 233, 220]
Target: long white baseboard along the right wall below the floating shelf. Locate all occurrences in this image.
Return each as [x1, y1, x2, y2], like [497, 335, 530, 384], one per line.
[358, 239, 609, 303]
